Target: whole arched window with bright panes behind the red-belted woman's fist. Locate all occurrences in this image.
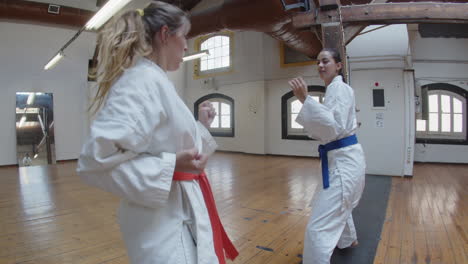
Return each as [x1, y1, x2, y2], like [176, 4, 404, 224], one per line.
[194, 93, 234, 137]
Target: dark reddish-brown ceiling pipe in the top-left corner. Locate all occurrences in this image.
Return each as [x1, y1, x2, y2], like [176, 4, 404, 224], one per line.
[0, 0, 94, 29]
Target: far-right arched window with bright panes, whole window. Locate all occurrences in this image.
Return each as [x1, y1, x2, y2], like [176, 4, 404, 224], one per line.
[416, 83, 467, 144]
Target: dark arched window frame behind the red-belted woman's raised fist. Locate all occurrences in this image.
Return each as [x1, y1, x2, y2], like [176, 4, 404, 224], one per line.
[193, 93, 235, 137]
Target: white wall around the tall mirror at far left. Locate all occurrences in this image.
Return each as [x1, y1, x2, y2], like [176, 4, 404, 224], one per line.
[0, 22, 95, 165]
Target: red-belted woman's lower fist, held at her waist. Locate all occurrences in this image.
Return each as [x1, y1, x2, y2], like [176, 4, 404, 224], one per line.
[175, 148, 208, 172]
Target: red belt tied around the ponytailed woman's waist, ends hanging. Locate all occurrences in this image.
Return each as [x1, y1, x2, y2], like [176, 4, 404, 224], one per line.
[173, 171, 239, 264]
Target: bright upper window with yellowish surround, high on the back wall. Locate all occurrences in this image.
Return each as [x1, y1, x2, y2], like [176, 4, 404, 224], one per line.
[194, 32, 233, 78]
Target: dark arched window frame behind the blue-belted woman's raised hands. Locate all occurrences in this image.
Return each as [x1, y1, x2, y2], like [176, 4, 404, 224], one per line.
[281, 85, 325, 140]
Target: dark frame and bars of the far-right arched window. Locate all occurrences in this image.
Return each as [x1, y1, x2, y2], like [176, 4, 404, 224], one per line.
[415, 83, 468, 145]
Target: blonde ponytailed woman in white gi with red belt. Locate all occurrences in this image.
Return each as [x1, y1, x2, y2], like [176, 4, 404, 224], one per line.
[77, 1, 237, 264]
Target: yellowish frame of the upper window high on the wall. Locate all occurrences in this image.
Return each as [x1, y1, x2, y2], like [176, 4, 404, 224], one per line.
[193, 31, 234, 79]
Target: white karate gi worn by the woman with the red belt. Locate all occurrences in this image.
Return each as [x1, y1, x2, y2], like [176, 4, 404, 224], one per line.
[77, 58, 218, 264]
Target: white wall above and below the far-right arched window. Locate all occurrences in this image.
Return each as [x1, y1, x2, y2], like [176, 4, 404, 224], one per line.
[409, 24, 468, 163]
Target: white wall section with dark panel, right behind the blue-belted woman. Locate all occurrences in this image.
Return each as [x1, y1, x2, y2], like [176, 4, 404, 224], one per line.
[352, 69, 405, 176]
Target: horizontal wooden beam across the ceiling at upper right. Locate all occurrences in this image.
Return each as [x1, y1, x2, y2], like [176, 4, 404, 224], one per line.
[292, 2, 468, 28]
